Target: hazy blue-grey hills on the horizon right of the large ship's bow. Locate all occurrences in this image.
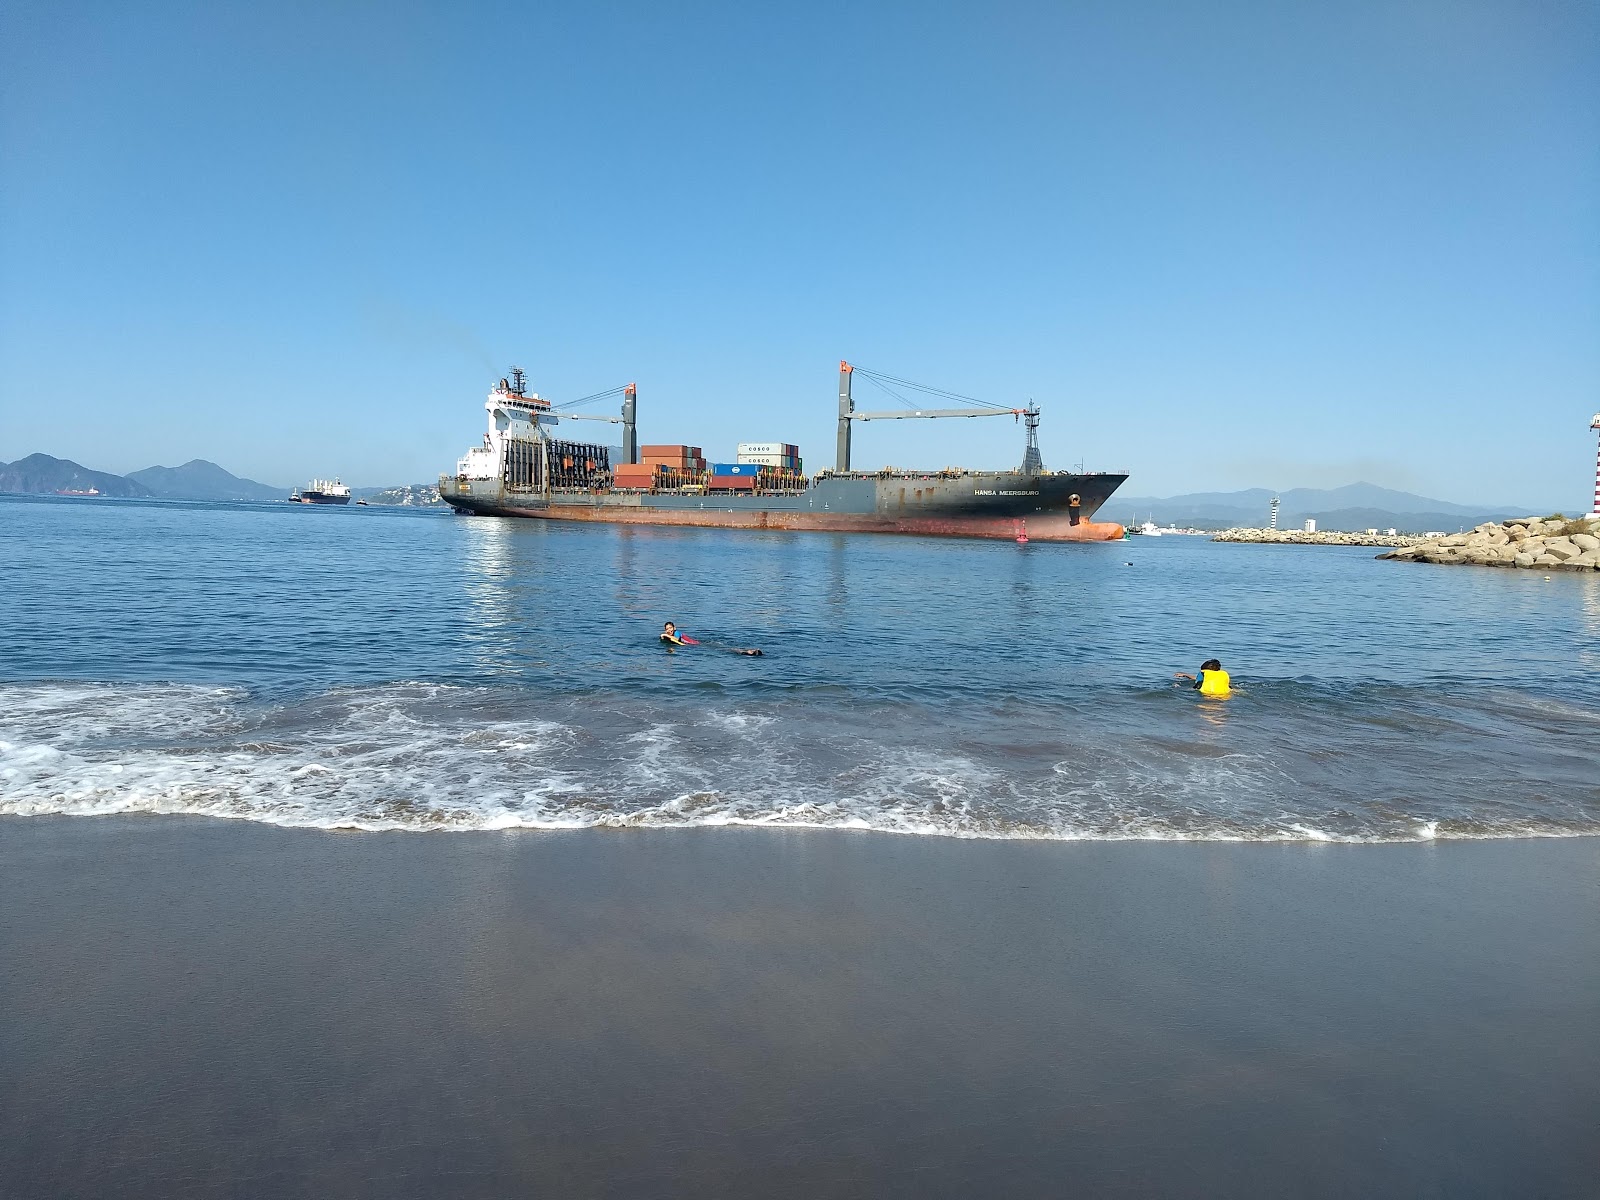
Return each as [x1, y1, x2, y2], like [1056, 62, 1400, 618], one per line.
[1096, 483, 1531, 533]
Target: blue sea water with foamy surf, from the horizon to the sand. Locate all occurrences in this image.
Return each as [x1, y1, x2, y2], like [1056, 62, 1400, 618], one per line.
[0, 496, 1600, 842]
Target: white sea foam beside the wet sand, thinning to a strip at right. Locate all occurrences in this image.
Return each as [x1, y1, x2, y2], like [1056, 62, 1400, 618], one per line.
[0, 683, 1600, 842]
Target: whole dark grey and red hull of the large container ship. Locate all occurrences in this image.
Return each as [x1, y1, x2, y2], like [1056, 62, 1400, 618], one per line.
[440, 474, 1126, 542]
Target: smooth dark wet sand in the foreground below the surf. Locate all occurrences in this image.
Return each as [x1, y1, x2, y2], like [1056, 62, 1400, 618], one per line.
[0, 818, 1600, 1197]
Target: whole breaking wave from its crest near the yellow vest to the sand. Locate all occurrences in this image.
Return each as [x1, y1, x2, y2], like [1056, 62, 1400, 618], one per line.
[0, 683, 1600, 842]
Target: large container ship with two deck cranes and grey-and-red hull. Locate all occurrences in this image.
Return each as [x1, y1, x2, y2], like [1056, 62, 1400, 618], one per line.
[438, 363, 1128, 542]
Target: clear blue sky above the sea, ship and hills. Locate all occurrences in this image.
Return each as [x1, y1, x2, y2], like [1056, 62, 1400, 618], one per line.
[0, 0, 1600, 509]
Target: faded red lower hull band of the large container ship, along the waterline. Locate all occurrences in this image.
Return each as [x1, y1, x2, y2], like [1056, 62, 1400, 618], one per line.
[480, 504, 1123, 542]
